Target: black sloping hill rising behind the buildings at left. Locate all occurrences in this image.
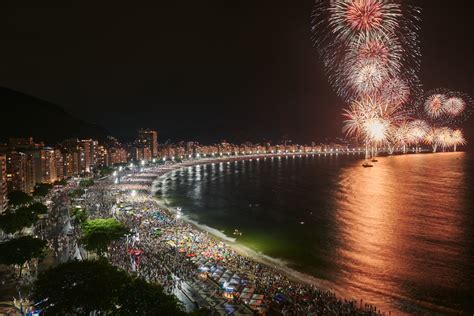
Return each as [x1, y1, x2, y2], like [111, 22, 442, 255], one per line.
[0, 87, 107, 144]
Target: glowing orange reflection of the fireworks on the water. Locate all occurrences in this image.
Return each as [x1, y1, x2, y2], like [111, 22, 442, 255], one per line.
[336, 153, 473, 311]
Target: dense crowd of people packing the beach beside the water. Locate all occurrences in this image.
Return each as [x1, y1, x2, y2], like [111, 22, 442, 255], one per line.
[70, 160, 382, 315]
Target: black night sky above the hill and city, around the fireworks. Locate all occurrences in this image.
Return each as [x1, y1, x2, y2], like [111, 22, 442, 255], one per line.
[0, 0, 474, 142]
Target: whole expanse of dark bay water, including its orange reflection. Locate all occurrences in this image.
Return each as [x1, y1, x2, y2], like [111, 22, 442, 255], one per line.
[157, 153, 474, 314]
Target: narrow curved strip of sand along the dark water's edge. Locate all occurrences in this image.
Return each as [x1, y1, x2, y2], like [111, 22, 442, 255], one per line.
[150, 152, 360, 303]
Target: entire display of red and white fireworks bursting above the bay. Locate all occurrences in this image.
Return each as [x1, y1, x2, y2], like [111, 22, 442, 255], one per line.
[312, 0, 472, 152]
